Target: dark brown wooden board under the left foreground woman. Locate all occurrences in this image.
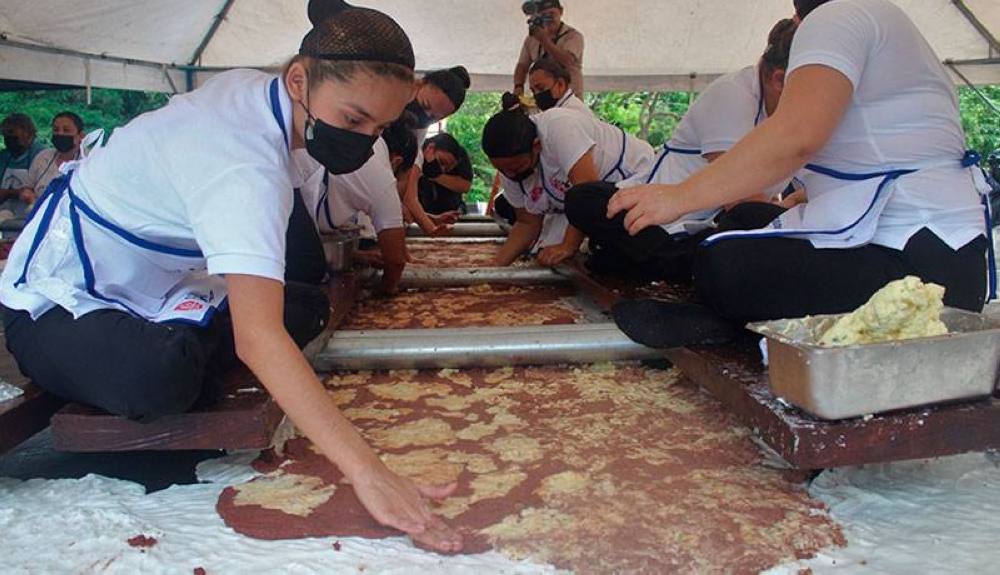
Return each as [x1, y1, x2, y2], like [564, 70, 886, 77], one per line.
[52, 274, 358, 451]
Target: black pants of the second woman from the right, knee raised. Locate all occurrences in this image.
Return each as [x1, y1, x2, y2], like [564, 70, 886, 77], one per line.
[566, 182, 784, 283]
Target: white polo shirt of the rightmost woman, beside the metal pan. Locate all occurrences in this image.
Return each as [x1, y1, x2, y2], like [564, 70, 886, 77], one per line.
[788, 0, 985, 249]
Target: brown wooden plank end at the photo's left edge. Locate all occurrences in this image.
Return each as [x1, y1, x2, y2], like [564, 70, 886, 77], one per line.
[0, 334, 66, 454]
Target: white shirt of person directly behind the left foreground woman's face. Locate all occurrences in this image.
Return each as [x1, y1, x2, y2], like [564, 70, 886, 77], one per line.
[292, 138, 403, 233]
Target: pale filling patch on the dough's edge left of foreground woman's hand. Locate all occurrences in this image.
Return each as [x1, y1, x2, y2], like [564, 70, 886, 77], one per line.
[233, 471, 337, 517]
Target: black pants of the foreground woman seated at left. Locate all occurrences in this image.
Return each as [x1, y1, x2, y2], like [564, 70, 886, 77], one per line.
[3, 189, 330, 421]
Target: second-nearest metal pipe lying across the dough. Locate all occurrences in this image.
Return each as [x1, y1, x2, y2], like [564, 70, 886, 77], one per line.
[386, 268, 569, 288]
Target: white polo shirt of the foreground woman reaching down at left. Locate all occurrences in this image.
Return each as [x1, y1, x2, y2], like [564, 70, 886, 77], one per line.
[0, 70, 301, 317]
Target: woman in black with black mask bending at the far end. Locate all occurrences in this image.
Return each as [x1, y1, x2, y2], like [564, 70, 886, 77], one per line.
[417, 133, 473, 214]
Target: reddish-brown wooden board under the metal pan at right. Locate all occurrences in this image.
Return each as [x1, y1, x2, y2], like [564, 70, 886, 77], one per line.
[563, 266, 1000, 470]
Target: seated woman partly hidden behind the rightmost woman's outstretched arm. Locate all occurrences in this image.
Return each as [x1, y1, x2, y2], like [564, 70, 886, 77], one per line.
[566, 19, 796, 284]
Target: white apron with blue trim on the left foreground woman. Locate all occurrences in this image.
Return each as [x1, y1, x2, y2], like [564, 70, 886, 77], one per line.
[14, 80, 288, 326]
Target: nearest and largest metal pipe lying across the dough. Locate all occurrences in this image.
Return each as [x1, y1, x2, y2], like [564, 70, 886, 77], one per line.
[313, 323, 663, 371]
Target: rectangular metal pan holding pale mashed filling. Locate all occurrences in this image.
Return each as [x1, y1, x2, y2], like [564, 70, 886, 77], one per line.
[747, 308, 1000, 419]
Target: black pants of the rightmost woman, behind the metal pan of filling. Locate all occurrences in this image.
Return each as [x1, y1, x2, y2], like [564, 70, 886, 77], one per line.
[694, 229, 987, 322]
